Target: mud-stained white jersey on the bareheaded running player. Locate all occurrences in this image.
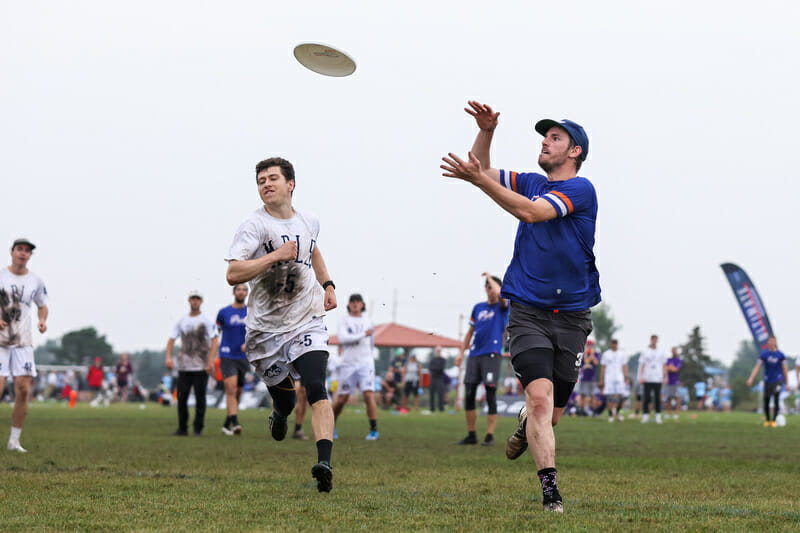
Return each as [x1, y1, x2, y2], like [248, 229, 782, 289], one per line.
[226, 207, 325, 333]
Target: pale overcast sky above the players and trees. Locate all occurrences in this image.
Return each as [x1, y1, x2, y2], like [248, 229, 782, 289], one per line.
[0, 0, 800, 362]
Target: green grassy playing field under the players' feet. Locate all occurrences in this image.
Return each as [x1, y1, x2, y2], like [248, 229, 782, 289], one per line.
[0, 404, 800, 531]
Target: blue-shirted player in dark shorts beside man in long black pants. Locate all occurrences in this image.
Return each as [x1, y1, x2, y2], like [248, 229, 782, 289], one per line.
[207, 283, 250, 435]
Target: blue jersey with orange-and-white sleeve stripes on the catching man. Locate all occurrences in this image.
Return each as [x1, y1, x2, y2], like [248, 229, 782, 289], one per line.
[500, 170, 600, 311]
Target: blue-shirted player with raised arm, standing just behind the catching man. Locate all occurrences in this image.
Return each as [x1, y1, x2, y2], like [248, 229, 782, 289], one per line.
[455, 272, 508, 446]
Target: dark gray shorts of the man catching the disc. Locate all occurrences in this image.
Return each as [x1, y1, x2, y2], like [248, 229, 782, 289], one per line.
[508, 301, 592, 383]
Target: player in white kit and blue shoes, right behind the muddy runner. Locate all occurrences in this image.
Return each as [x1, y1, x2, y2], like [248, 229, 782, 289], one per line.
[333, 294, 378, 440]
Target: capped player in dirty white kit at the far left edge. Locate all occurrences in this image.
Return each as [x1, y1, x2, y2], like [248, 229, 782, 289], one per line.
[0, 239, 48, 453]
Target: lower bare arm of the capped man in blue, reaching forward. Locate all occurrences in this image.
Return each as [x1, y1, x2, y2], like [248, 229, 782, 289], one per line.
[440, 152, 558, 224]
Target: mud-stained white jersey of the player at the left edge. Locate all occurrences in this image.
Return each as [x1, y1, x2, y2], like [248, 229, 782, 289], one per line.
[0, 268, 47, 348]
